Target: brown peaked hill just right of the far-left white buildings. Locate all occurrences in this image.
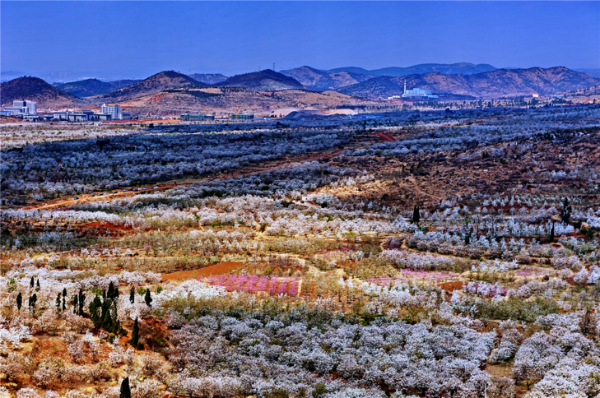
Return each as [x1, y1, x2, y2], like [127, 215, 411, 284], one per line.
[93, 71, 207, 102]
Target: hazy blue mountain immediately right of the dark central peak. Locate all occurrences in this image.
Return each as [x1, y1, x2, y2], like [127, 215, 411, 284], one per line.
[281, 66, 374, 91]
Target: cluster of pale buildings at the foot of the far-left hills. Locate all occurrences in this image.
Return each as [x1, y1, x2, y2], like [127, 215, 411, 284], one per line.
[0, 100, 131, 122]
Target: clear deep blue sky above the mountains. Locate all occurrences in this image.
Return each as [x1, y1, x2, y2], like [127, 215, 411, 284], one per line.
[0, 0, 600, 81]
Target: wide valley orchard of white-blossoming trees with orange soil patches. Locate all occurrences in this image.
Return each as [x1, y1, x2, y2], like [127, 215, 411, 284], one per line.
[0, 105, 600, 398]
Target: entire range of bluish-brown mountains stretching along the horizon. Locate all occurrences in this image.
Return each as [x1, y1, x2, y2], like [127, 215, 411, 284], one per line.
[0, 63, 600, 112]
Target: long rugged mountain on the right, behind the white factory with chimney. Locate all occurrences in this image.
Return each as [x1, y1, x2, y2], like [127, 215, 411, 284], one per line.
[338, 67, 599, 98]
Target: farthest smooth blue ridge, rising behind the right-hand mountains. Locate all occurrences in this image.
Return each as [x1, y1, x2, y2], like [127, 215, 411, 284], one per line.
[331, 62, 496, 77]
